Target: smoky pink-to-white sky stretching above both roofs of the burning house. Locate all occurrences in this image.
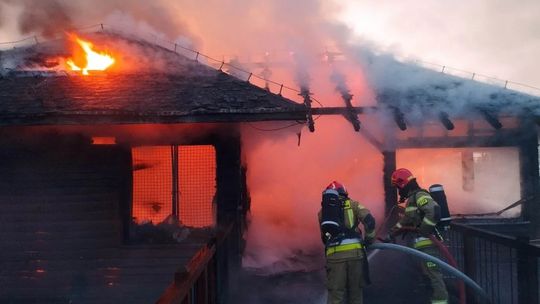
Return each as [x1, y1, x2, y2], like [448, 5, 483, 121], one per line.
[0, 0, 540, 86]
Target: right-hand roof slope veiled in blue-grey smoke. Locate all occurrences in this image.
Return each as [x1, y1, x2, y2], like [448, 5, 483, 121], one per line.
[364, 54, 540, 121]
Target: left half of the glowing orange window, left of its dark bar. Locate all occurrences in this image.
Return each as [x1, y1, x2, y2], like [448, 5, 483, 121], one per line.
[132, 146, 172, 224]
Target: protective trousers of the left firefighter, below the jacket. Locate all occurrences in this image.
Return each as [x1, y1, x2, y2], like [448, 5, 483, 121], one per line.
[326, 256, 364, 304]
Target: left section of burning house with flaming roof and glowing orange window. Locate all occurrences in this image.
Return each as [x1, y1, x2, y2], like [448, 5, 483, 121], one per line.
[0, 30, 305, 303]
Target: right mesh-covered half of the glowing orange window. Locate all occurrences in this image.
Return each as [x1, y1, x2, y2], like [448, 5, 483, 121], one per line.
[178, 145, 216, 227]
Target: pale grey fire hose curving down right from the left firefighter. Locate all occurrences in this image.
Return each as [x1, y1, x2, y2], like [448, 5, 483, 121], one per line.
[369, 243, 490, 303]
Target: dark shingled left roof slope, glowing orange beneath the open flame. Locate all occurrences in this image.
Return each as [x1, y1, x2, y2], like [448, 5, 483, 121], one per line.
[0, 37, 306, 126]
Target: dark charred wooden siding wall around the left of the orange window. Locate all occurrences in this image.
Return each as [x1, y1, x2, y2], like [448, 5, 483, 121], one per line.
[0, 136, 215, 303]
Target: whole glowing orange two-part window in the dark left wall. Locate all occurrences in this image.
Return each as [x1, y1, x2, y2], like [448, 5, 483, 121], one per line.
[132, 145, 216, 227]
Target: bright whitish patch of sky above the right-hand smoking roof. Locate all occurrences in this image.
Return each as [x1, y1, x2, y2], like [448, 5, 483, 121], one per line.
[341, 0, 540, 87]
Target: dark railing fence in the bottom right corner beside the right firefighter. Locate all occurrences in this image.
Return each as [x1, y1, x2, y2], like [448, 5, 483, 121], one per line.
[448, 223, 540, 304]
